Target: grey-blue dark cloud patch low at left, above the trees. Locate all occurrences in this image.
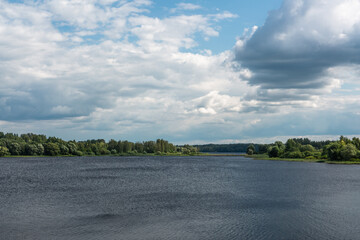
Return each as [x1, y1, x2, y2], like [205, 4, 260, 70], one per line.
[0, 83, 111, 121]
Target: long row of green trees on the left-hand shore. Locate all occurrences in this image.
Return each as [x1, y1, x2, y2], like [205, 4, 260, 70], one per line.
[0, 132, 198, 157]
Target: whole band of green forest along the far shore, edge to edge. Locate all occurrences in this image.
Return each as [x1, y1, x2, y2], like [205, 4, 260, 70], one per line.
[0, 132, 360, 161]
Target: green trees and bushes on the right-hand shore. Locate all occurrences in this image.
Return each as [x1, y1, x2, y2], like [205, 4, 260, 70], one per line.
[246, 136, 360, 161]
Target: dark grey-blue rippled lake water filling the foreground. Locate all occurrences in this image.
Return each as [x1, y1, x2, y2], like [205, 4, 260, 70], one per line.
[0, 156, 360, 240]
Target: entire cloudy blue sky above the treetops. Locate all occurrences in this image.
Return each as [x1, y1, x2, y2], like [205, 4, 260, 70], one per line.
[0, 0, 360, 144]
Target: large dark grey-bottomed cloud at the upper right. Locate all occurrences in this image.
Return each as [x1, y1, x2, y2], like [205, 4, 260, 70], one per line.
[235, 0, 360, 92]
